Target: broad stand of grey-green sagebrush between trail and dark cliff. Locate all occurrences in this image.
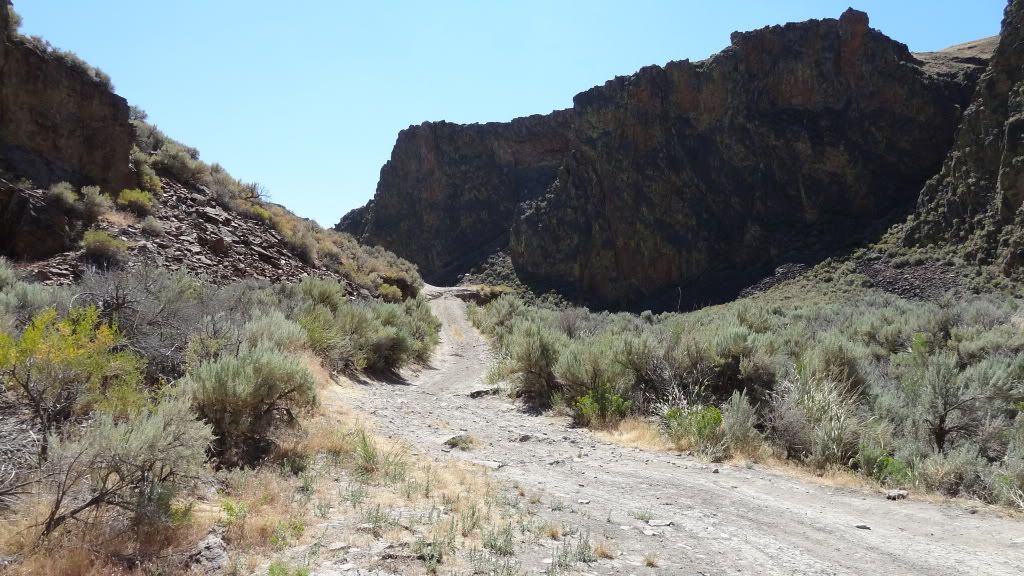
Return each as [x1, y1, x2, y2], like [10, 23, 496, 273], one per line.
[469, 280, 1024, 503]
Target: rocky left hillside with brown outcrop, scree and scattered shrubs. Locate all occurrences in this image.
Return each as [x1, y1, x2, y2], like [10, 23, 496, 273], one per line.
[0, 3, 422, 299]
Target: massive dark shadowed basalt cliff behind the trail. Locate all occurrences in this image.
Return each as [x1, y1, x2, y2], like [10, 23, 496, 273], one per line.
[339, 6, 991, 307]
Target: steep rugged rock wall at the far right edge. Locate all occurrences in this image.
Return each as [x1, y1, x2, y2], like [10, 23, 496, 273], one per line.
[904, 0, 1024, 270]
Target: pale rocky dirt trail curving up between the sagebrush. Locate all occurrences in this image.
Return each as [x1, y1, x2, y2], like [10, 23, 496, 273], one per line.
[356, 287, 1024, 575]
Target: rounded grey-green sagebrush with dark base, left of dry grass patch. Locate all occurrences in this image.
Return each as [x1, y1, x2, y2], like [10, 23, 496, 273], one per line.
[182, 343, 316, 465]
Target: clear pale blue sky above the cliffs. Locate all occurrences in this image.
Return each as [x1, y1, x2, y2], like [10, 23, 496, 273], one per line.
[14, 0, 1006, 225]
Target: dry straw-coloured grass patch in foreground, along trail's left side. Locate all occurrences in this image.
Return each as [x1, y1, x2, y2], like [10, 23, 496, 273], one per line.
[225, 358, 520, 566]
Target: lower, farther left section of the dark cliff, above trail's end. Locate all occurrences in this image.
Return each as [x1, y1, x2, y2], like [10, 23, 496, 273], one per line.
[337, 112, 570, 283]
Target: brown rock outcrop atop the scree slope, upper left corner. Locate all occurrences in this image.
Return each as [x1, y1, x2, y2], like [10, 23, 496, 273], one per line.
[0, 0, 134, 192]
